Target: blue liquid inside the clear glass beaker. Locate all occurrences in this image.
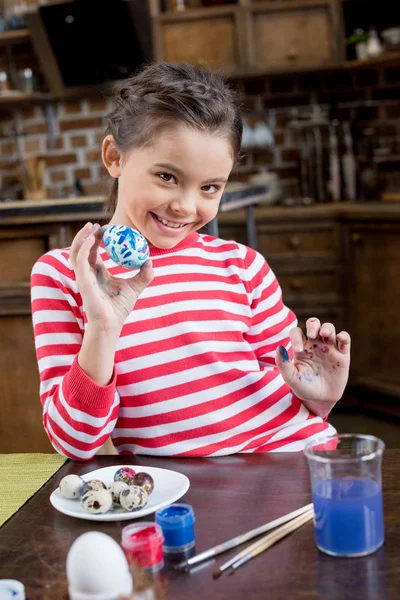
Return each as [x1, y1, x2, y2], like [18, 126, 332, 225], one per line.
[312, 479, 384, 556]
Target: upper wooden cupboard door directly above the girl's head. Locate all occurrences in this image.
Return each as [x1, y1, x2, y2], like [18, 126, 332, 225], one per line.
[160, 15, 239, 72]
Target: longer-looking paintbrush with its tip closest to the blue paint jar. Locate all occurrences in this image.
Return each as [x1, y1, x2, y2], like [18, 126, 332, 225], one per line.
[174, 504, 313, 572]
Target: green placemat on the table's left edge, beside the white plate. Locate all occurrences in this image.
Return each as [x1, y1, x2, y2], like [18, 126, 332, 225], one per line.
[0, 454, 67, 526]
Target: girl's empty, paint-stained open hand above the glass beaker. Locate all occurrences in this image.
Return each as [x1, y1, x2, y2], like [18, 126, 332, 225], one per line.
[276, 318, 350, 403]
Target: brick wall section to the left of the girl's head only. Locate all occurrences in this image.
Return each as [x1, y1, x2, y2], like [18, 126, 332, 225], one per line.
[0, 99, 109, 198]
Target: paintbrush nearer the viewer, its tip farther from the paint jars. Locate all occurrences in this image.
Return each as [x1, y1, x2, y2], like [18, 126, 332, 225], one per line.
[217, 508, 314, 578]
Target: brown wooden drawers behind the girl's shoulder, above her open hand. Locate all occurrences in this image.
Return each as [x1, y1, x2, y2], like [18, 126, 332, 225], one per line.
[220, 208, 343, 331]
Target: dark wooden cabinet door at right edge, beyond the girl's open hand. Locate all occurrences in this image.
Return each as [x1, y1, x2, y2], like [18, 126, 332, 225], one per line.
[347, 220, 400, 396]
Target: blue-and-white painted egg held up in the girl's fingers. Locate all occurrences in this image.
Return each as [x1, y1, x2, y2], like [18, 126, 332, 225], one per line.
[103, 225, 150, 269]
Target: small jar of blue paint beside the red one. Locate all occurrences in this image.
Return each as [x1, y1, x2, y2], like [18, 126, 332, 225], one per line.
[155, 504, 196, 553]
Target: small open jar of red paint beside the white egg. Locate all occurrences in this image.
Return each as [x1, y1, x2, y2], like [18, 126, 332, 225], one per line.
[121, 521, 164, 573]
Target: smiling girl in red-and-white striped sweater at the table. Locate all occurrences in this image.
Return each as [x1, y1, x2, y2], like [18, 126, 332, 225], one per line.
[32, 64, 350, 460]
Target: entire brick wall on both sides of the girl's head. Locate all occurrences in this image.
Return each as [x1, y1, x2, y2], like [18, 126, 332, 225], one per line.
[0, 66, 400, 202]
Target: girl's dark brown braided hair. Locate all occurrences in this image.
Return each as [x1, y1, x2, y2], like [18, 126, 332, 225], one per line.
[106, 63, 242, 214]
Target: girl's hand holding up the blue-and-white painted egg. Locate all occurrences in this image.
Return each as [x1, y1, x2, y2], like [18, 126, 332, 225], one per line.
[70, 223, 154, 334]
